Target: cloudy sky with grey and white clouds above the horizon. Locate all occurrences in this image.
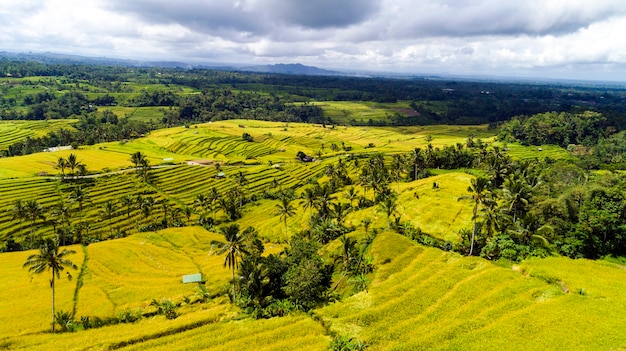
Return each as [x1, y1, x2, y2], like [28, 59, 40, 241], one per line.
[0, 0, 626, 81]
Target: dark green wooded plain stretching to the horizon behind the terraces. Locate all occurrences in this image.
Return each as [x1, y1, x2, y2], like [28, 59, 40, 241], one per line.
[0, 59, 626, 154]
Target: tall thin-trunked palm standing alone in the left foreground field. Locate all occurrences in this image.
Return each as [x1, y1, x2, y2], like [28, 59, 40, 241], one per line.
[23, 239, 78, 332]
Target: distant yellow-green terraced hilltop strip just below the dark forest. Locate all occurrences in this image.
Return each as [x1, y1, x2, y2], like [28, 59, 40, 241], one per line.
[0, 120, 492, 178]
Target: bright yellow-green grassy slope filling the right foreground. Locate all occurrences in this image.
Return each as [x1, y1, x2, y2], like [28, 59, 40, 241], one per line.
[319, 233, 626, 350]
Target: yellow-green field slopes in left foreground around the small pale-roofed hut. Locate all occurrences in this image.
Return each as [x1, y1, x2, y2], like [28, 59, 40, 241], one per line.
[0, 227, 328, 350]
